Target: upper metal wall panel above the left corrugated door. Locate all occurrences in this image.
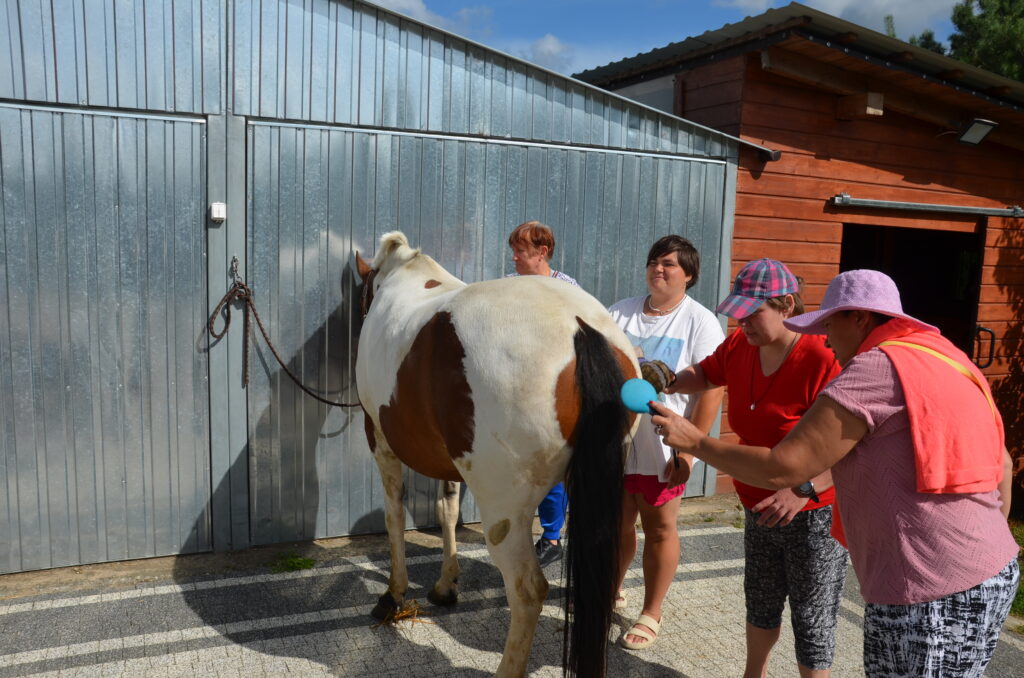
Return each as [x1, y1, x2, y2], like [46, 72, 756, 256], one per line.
[0, 0, 228, 113]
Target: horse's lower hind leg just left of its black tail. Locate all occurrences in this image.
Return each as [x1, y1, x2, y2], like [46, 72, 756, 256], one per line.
[478, 512, 548, 678]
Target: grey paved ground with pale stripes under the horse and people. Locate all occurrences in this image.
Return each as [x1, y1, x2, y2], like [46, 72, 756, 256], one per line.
[0, 496, 1024, 678]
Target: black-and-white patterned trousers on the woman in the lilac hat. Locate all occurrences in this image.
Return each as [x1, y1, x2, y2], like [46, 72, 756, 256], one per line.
[864, 558, 1020, 678]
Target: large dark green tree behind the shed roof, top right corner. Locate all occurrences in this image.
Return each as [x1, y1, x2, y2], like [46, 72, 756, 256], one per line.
[942, 0, 1024, 80]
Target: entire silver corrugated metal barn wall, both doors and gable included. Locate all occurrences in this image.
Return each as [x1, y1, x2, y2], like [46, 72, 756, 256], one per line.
[0, 0, 737, 571]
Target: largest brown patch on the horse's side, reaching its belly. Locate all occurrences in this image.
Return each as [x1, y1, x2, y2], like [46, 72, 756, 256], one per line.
[380, 312, 474, 481]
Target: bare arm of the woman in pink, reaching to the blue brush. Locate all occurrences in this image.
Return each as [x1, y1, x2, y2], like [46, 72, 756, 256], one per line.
[651, 396, 867, 490]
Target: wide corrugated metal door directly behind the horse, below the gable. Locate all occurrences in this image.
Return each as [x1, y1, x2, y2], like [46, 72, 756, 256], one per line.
[242, 122, 725, 543]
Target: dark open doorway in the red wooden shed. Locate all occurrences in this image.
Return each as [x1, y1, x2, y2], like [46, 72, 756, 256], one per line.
[840, 223, 985, 356]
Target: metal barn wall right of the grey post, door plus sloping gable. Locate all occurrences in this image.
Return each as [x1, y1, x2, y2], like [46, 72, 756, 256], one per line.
[231, 0, 734, 543]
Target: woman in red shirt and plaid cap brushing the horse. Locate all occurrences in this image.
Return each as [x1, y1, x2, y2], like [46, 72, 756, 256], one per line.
[666, 259, 848, 678]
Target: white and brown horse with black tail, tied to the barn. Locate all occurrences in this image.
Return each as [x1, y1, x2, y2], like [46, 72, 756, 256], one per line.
[355, 231, 640, 678]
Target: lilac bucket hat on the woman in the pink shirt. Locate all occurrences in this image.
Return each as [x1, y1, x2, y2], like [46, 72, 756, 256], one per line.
[782, 268, 939, 334]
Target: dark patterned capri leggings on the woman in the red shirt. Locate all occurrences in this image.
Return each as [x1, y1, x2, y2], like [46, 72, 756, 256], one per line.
[743, 506, 849, 669]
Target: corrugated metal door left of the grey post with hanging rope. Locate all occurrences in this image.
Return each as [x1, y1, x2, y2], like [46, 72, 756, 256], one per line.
[0, 105, 210, 571]
